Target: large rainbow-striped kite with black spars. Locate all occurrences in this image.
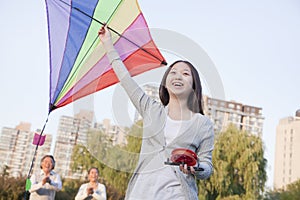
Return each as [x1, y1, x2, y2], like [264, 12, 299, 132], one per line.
[45, 0, 166, 113]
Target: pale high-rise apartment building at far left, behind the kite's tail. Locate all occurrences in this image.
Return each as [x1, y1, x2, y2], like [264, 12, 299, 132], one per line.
[0, 122, 52, 177]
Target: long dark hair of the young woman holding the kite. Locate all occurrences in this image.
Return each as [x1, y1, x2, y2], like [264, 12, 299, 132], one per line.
[159, 60, 204, 115]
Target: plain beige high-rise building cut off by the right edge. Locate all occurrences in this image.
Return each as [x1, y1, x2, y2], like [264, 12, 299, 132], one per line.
[274, 110, 300, 189]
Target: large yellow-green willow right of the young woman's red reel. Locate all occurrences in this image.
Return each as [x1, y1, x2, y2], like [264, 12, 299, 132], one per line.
[199, 125, 267, 199]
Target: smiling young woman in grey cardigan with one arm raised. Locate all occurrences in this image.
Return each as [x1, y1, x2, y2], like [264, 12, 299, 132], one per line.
[99, 26, 214, 200]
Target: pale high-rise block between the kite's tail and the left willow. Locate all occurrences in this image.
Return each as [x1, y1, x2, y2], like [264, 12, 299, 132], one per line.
[54, 110, 126, 179]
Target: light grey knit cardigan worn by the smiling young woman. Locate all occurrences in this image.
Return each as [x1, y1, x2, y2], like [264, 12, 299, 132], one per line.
[108, 49, 214, 200]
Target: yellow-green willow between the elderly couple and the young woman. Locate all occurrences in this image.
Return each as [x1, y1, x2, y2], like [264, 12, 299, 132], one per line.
[72, 122, 142, 199]
